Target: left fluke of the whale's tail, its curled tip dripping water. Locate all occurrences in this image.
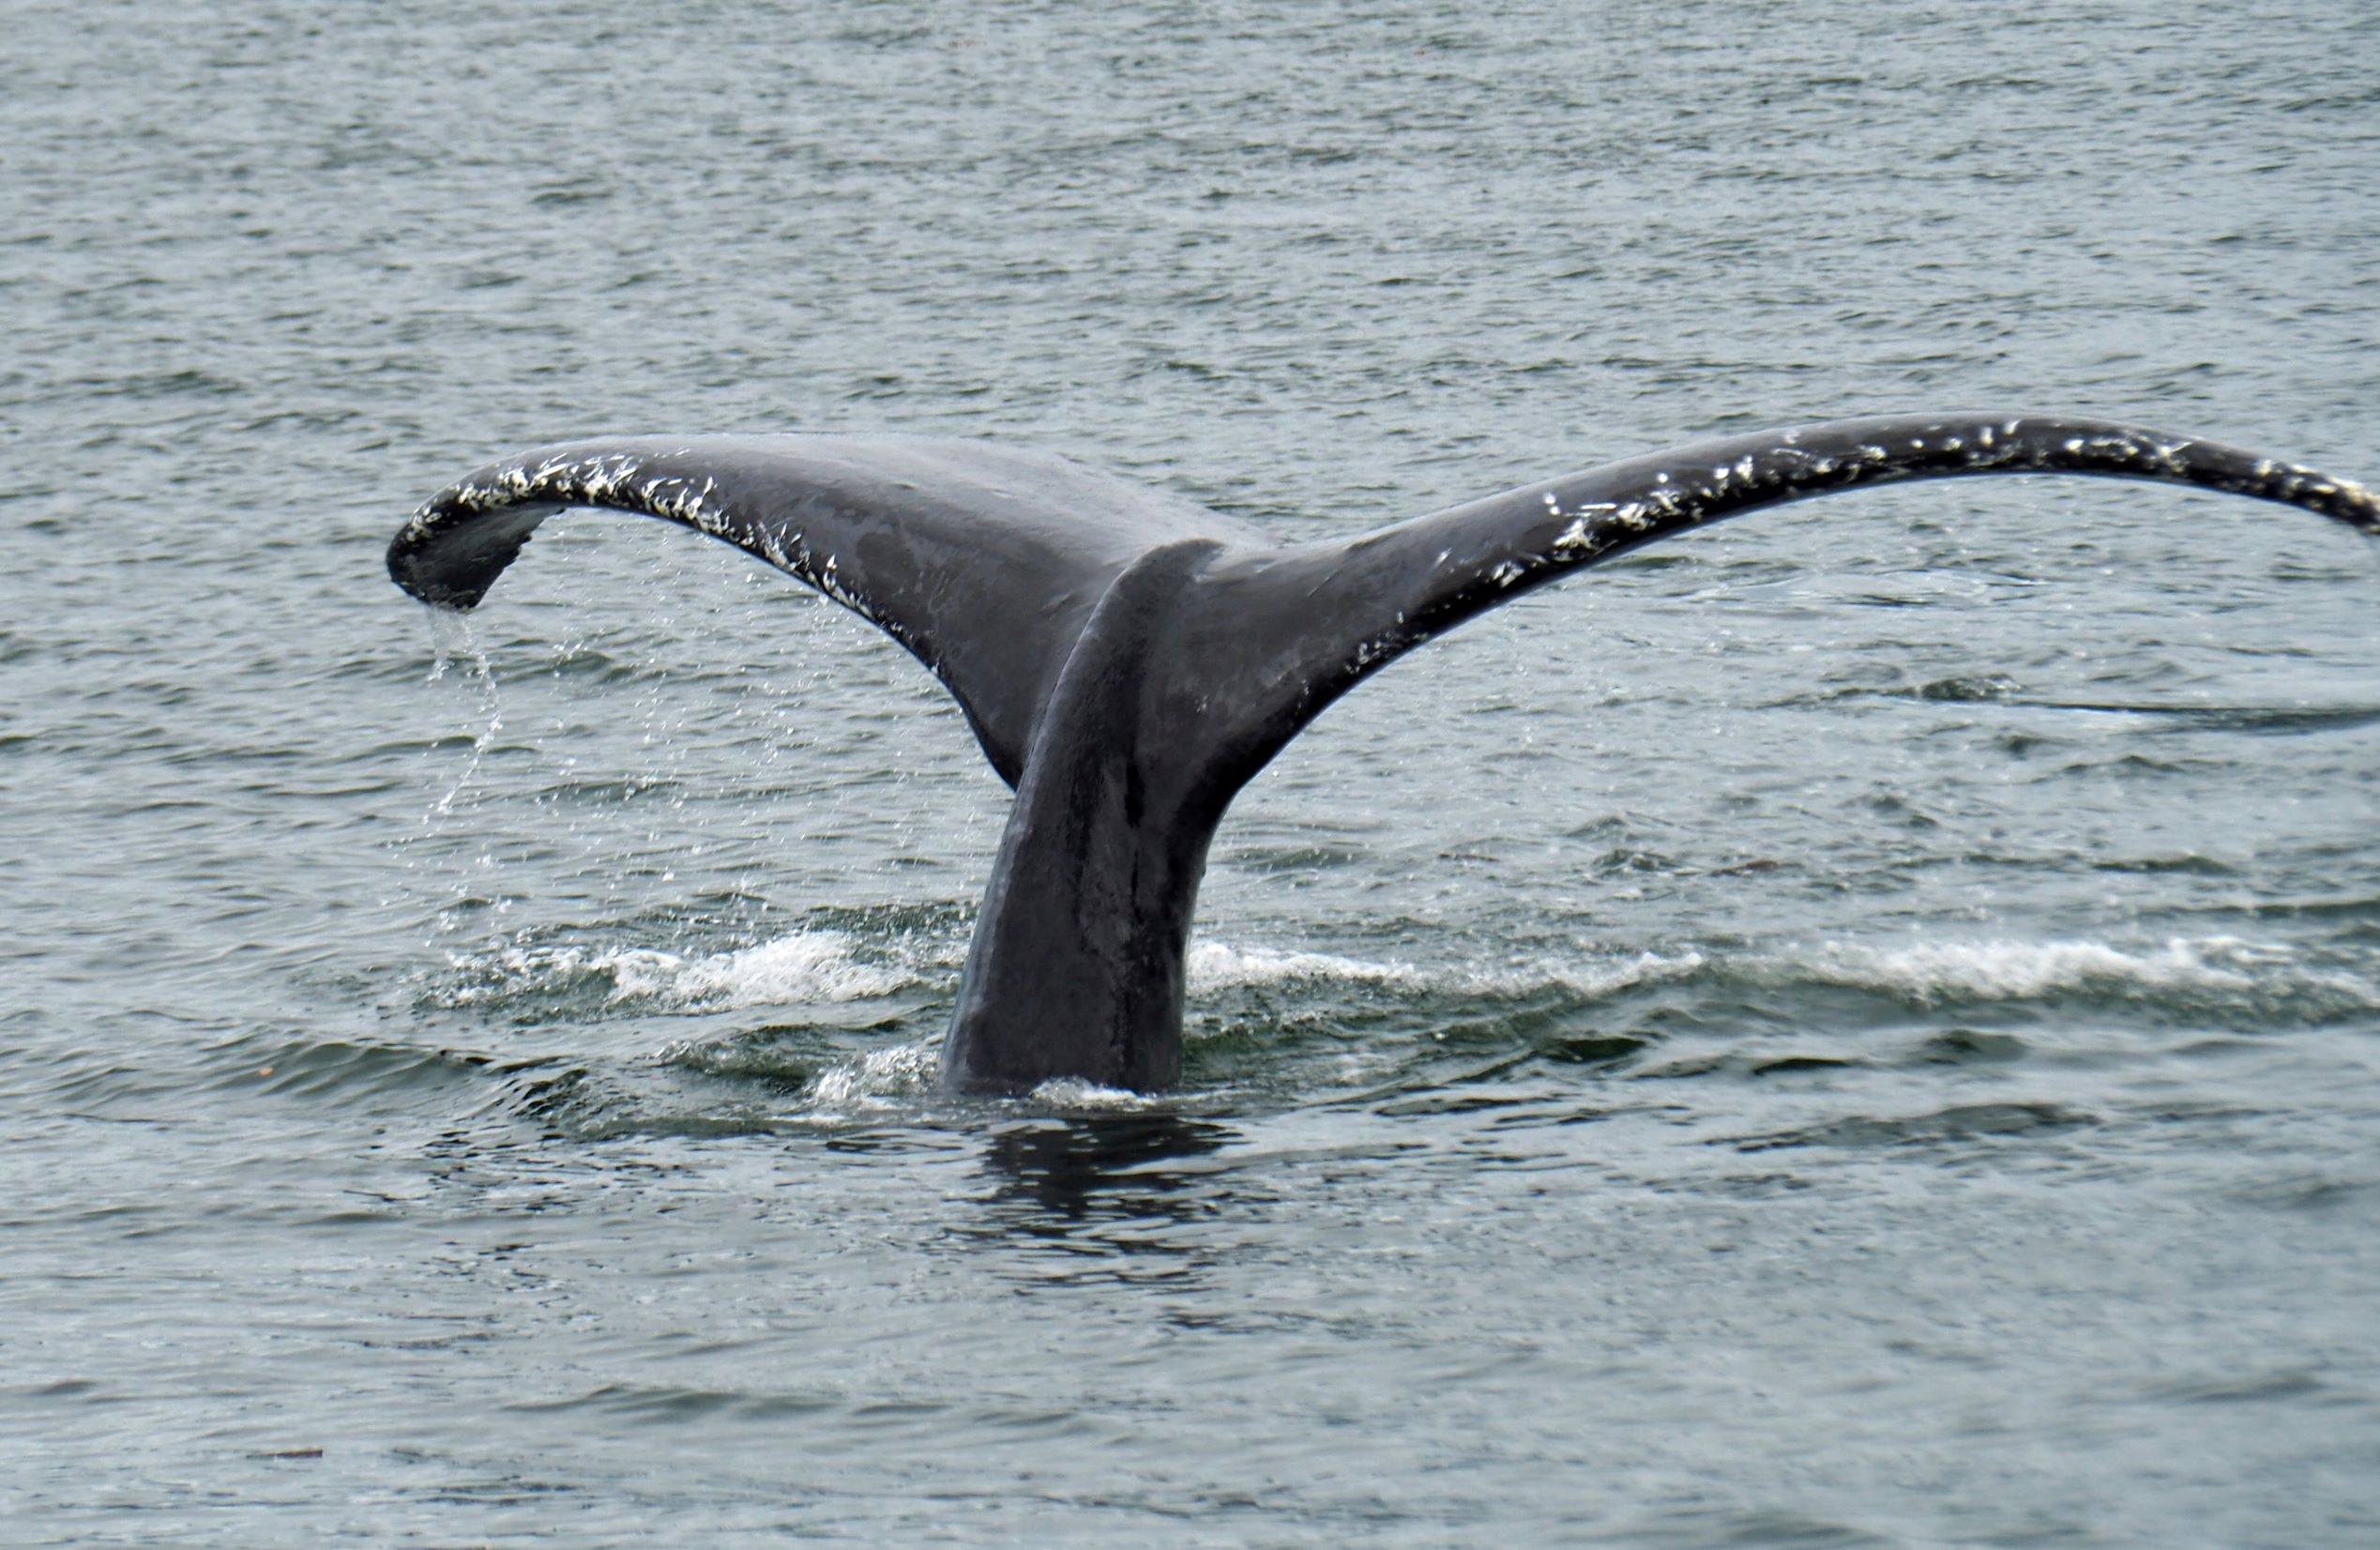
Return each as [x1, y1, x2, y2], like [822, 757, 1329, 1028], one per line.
[388, 435, 1268, 785]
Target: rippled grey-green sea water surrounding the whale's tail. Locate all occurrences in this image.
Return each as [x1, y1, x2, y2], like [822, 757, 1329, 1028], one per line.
[0, 0, 2380, 1547]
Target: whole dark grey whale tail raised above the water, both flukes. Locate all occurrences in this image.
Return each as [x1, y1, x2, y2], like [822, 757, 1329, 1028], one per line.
[388, 412, 2380, 1093]
